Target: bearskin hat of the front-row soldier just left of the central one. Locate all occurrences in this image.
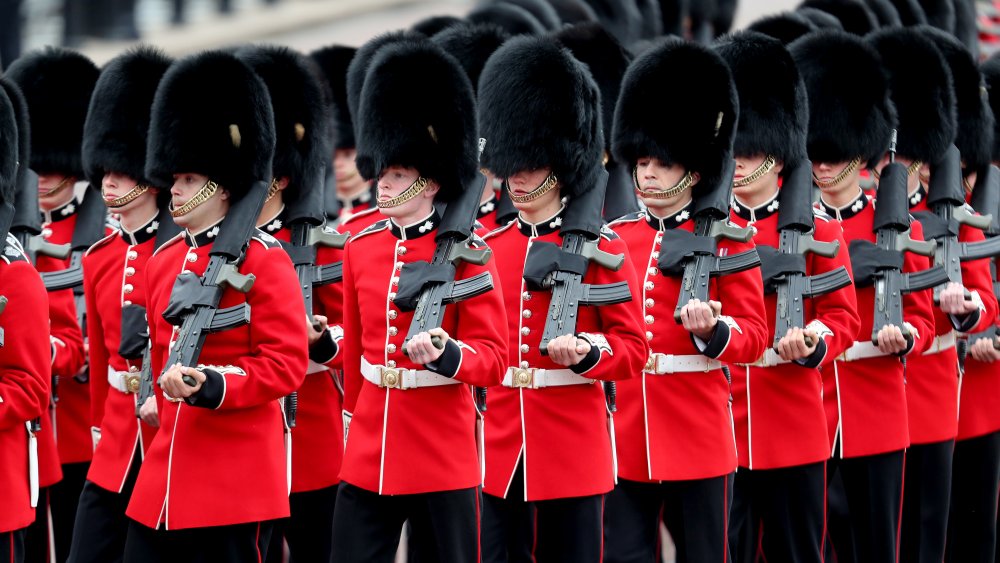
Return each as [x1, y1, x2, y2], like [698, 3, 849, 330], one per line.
[356, 39, 479, 201]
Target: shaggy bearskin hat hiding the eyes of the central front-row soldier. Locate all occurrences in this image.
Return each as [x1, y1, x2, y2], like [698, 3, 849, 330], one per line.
[479, 37, 604, 196]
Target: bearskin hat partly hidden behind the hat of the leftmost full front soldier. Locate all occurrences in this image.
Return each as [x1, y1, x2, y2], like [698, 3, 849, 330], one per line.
[83, 47, 173, 188]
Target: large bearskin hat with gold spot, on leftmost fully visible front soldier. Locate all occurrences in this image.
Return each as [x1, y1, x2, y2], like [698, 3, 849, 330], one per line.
[146, 51, 275, 198]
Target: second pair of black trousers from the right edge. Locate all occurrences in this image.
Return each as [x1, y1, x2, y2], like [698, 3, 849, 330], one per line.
[899, 440, 955, 563]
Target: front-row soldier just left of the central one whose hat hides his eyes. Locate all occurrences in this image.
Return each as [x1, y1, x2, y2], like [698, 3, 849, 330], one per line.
[333, 37, 507, 562]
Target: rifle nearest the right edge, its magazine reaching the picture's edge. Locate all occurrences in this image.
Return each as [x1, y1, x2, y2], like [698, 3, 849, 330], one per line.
[915, 145, 1000, 303]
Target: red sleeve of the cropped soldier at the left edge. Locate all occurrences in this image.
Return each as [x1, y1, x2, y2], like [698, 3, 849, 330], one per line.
[0, 262, 50, 430]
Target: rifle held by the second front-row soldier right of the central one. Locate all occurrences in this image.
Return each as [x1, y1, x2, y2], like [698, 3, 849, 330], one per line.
[760, 160, 851, 347]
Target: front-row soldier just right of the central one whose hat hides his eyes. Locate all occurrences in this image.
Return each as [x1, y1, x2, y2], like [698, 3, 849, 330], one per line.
[605, 39, 767, 561]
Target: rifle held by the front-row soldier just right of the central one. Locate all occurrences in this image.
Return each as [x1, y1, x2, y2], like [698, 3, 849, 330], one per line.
[657, 158, 760, 323]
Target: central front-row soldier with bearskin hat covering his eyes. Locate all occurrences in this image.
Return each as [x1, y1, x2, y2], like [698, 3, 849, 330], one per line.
[479, 37, 646, 562]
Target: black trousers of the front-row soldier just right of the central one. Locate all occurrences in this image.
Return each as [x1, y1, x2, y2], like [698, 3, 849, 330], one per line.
[604, 474, 733, 563]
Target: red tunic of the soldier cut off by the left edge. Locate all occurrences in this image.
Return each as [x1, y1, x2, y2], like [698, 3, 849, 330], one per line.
[0, 235, 52, 533]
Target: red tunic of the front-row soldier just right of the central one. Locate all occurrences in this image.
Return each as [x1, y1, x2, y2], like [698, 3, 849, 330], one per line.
[612, 208, 769, 481]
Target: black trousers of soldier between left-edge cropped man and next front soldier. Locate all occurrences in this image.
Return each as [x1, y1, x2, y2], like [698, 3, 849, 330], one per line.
[68, 450, 142, 563]
